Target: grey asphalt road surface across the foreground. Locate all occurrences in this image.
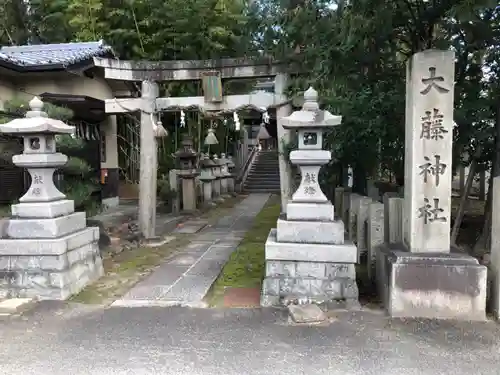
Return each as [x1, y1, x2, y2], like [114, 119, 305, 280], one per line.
[0, 302, 500, 375]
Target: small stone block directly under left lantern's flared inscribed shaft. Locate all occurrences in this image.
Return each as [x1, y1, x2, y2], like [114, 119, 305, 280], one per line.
[12, 199, 75, 219]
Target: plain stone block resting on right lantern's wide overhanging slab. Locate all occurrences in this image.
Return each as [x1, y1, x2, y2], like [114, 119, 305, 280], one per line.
[276, 217, 344, 245]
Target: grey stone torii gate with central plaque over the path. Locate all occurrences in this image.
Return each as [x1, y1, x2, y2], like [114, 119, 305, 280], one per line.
[94, 58, 292, 239]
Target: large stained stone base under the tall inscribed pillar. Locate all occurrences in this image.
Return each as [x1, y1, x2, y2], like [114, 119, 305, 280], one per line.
[377, 245, 487, 320]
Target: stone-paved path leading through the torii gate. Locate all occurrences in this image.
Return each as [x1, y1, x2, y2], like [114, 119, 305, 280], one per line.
[112, 194, 269, 307]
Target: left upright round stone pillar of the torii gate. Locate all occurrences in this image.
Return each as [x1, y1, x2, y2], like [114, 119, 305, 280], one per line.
[139, 81, 159, 239]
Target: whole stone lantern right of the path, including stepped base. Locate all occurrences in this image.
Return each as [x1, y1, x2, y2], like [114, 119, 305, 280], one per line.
[261, 88, 358, 306]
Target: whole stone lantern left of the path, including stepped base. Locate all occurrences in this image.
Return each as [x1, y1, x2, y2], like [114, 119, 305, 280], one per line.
[0, 97, 104, 300]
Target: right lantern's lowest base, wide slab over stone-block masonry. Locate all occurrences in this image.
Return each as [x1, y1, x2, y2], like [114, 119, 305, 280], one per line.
[261, 229, 358, 306]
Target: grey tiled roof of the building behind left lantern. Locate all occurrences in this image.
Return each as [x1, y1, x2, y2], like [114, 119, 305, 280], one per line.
[0, 41, 114, 71]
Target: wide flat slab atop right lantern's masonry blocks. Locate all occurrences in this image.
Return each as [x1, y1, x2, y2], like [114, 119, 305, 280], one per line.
[265, 229, 358, 263]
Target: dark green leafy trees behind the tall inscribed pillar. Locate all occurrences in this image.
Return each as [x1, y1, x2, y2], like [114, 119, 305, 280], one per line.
[252, 0, 500, 192]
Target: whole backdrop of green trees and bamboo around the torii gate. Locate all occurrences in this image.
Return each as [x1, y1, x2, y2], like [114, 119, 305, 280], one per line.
[0, 0, 500, 204]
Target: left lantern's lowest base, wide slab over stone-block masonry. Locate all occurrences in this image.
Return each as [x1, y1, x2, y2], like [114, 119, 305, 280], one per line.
[0, 227, 104, 300]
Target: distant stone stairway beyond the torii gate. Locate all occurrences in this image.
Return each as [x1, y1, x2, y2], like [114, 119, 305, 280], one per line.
[243, 150, 280, 193]
